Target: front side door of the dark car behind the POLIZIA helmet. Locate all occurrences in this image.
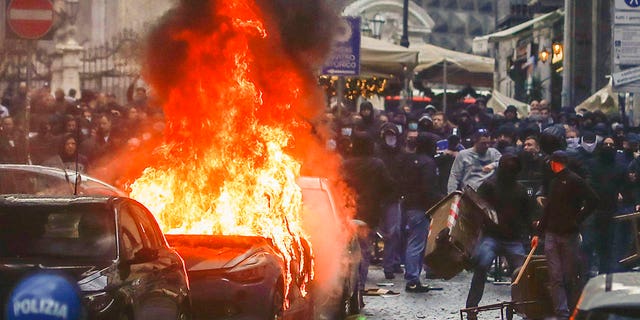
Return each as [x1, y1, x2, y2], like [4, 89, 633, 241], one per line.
[118, 202, 177, 319]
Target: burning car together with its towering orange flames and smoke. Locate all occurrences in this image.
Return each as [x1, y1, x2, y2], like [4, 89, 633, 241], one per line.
[127, 0, 353, 319]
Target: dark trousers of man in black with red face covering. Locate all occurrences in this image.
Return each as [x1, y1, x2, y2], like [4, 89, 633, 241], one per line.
[544, 232, 582, 319]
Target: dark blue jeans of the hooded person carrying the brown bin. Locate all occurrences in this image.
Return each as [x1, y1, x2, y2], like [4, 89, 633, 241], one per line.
[467, 236, 526, 308]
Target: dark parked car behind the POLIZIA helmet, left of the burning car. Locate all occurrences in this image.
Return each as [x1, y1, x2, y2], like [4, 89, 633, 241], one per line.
[0, 195, 191, 319]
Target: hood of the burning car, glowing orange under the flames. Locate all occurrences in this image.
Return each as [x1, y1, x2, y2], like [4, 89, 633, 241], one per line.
[166, 234, 275, 271]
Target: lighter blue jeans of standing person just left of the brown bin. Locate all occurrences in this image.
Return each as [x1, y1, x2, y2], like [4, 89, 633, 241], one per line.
[404, 210, 429, 283]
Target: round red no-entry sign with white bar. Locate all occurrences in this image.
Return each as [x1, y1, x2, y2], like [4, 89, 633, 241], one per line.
[7, 0, 53, 39]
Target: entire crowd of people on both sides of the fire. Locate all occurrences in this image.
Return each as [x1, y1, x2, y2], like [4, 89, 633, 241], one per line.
[0, 83, 640, 318]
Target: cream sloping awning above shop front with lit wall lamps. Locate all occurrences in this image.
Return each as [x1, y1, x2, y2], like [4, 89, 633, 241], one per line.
[473, 9, 564, 54]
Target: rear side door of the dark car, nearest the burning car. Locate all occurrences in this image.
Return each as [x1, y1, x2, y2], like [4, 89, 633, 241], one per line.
[129, 202, 188, 317]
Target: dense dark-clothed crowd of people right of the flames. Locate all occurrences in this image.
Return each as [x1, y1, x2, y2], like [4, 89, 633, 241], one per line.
[332, 99, 640, 319]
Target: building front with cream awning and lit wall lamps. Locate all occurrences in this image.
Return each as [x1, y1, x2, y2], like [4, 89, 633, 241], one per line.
[473, 0, 612, 110]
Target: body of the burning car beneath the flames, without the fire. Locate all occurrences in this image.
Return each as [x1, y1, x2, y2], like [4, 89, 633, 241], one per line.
[166, 234, 311, 319]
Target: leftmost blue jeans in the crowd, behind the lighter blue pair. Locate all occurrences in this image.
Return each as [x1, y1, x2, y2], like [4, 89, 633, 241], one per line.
[382, 201, 402, 273]
